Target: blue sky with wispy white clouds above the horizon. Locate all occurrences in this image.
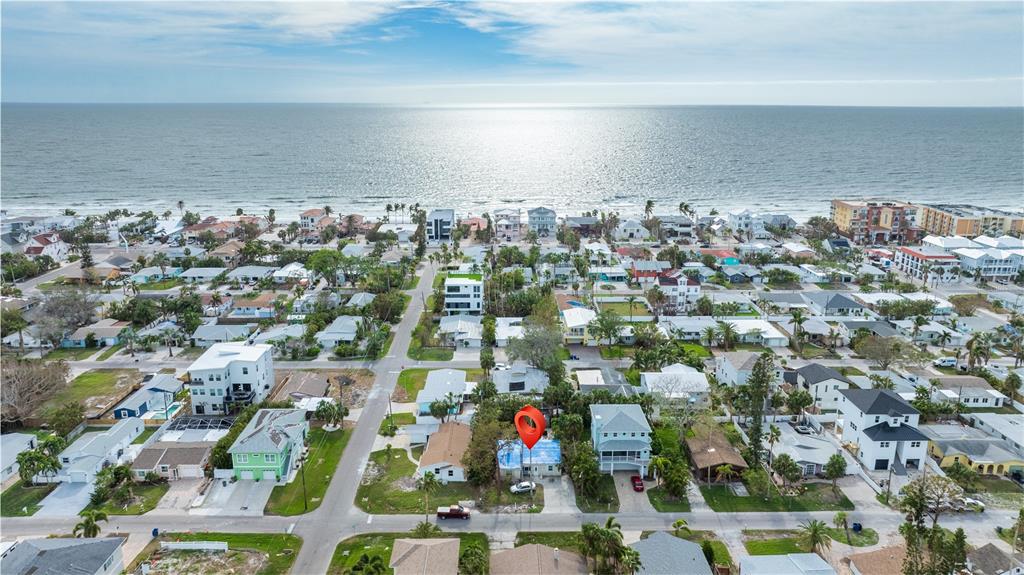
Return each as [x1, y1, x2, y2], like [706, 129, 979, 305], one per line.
[0, 1, 1024, 106]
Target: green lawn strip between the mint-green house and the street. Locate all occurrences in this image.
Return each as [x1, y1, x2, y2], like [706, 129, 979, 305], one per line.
[263, 429, 352, 516]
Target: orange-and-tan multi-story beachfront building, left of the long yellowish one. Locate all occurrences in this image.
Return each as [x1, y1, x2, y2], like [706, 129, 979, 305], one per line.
[831, 200, 922, 244]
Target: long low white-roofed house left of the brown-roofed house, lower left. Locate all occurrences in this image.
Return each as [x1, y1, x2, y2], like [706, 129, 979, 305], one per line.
[49, 417, 145, 483]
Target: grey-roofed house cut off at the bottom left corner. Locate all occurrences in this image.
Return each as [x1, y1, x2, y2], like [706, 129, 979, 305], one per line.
[0, 537, 126, 575]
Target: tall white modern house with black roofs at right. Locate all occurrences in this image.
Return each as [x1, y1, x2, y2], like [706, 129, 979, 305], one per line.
[836, 389, 928, 473]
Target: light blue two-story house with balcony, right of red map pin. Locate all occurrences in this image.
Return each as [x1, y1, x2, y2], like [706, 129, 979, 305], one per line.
[590, 403, 651, 475]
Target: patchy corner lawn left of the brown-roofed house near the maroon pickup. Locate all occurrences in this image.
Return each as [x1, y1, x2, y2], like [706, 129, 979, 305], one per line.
[355, 449, 476, 517]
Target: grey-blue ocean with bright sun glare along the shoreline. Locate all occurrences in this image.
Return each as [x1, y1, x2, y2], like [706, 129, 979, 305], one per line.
[0, 103, 1024, 219]
